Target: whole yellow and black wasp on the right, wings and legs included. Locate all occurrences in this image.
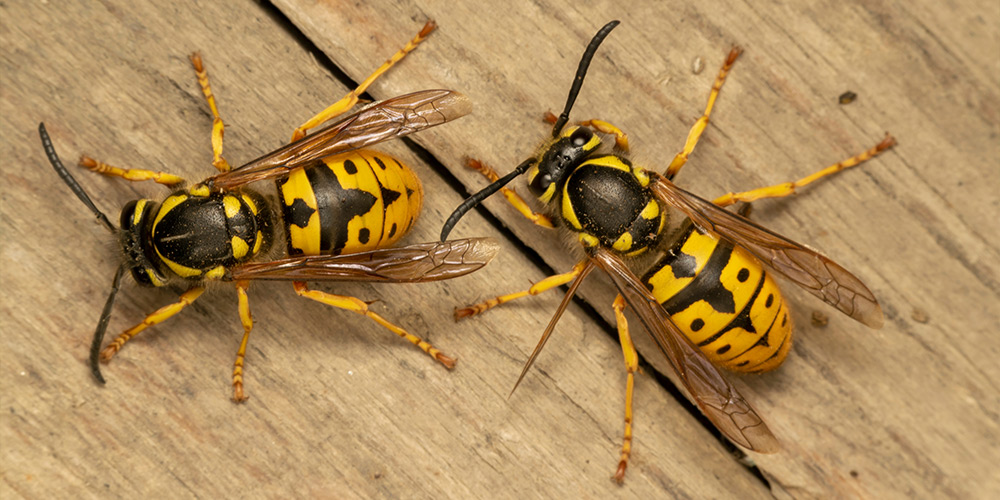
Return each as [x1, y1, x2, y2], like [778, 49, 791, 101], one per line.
[441, 21, 895, 483]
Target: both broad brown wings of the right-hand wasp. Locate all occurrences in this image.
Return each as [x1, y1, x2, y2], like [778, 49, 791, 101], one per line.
[588, 172, 883, 453]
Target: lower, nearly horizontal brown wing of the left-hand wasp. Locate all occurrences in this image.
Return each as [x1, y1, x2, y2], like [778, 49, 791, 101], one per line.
[231, 238, 500, 283]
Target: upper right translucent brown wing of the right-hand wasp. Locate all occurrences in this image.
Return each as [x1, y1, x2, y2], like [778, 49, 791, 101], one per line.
[651, 173, 884, 328]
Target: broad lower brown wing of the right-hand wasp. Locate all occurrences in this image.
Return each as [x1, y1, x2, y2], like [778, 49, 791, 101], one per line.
[591, 248, 780, 453]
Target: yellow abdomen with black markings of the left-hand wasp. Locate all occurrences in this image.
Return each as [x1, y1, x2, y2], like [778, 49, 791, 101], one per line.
[278, 151, 423, 255]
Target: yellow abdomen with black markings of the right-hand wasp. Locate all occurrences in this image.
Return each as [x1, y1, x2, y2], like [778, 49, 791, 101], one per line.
[643, 225, 792, 372]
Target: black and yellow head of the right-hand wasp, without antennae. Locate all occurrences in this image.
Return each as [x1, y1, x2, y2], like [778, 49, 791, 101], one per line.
[528, 126, 601, 203]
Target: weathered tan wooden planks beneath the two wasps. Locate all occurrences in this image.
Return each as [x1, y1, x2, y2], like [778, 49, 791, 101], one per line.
[0, 0, 1000, 498]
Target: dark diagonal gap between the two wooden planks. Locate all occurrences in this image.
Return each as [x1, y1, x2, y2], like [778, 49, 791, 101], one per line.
[260, 1, 771, 490]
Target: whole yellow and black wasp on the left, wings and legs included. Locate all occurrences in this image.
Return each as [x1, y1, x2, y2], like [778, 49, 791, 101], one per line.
[38, 22, 498, 402]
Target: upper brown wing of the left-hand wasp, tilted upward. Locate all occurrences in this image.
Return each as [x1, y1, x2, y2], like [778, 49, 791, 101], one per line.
[206, 90, 472, 190]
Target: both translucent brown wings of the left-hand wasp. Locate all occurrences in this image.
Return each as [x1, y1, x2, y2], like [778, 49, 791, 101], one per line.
[205, 90, 499, 283]
